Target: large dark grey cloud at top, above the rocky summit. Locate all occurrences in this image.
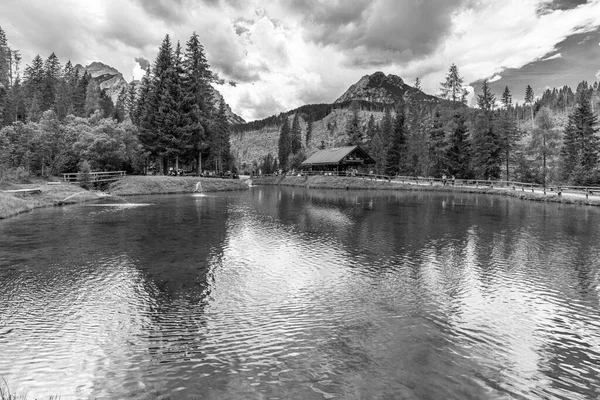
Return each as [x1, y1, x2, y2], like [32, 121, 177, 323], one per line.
[278, 0, 463, 67]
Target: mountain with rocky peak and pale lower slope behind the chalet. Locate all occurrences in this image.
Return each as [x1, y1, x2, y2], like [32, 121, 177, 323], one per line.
[231, 72, 445, 168]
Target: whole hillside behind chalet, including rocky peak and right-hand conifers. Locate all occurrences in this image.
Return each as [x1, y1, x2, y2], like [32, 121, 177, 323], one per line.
[232, 65, 600, 185]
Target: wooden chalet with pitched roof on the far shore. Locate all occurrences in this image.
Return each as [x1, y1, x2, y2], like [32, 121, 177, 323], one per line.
[300, 145, 375, 172]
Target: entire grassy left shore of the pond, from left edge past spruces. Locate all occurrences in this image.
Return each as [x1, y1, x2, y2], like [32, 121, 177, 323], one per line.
[0, 175, 248, 220]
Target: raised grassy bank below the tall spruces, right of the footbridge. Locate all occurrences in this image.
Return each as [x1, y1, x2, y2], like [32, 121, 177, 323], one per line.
[107, 175, 248, 196]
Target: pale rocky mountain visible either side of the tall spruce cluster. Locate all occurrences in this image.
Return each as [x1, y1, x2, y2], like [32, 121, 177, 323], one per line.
[75, 61, 246, 125]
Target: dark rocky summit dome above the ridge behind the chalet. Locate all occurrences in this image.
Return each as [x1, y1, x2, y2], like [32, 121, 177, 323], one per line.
[335, 71, 440, 104]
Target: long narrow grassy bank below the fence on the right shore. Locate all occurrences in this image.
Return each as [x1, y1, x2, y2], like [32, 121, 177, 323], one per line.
[252, 175, 600, 206]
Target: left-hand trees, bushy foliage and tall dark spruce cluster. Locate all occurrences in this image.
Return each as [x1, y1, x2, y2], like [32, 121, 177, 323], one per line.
[0, 28, 234, 179]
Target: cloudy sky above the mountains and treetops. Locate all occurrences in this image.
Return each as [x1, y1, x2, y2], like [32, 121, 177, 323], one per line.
[0, 0, 600, 121]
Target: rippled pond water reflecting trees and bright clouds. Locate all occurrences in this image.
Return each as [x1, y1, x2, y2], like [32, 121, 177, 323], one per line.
[0, 187, 600, 399]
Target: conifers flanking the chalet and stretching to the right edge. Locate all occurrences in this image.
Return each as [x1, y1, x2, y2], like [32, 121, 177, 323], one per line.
[274, 64, 600, 185]
